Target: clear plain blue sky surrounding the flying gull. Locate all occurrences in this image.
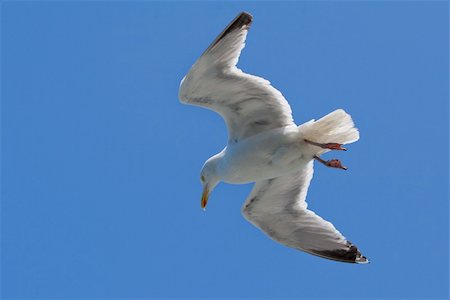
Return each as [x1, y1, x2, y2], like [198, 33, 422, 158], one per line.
[1, 1, 449, 299]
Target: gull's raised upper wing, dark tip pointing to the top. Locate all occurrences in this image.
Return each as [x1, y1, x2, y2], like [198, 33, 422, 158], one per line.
[179, 12, 294, 142]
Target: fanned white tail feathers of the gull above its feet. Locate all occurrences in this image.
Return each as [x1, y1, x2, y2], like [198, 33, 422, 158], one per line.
[299, 109, 359, 144]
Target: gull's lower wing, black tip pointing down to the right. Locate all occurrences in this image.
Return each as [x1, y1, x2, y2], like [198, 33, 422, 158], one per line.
[242, 161, 368, 263]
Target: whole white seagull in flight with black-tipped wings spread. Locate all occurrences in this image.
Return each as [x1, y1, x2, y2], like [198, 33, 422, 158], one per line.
[179, 12, 369, 264]
